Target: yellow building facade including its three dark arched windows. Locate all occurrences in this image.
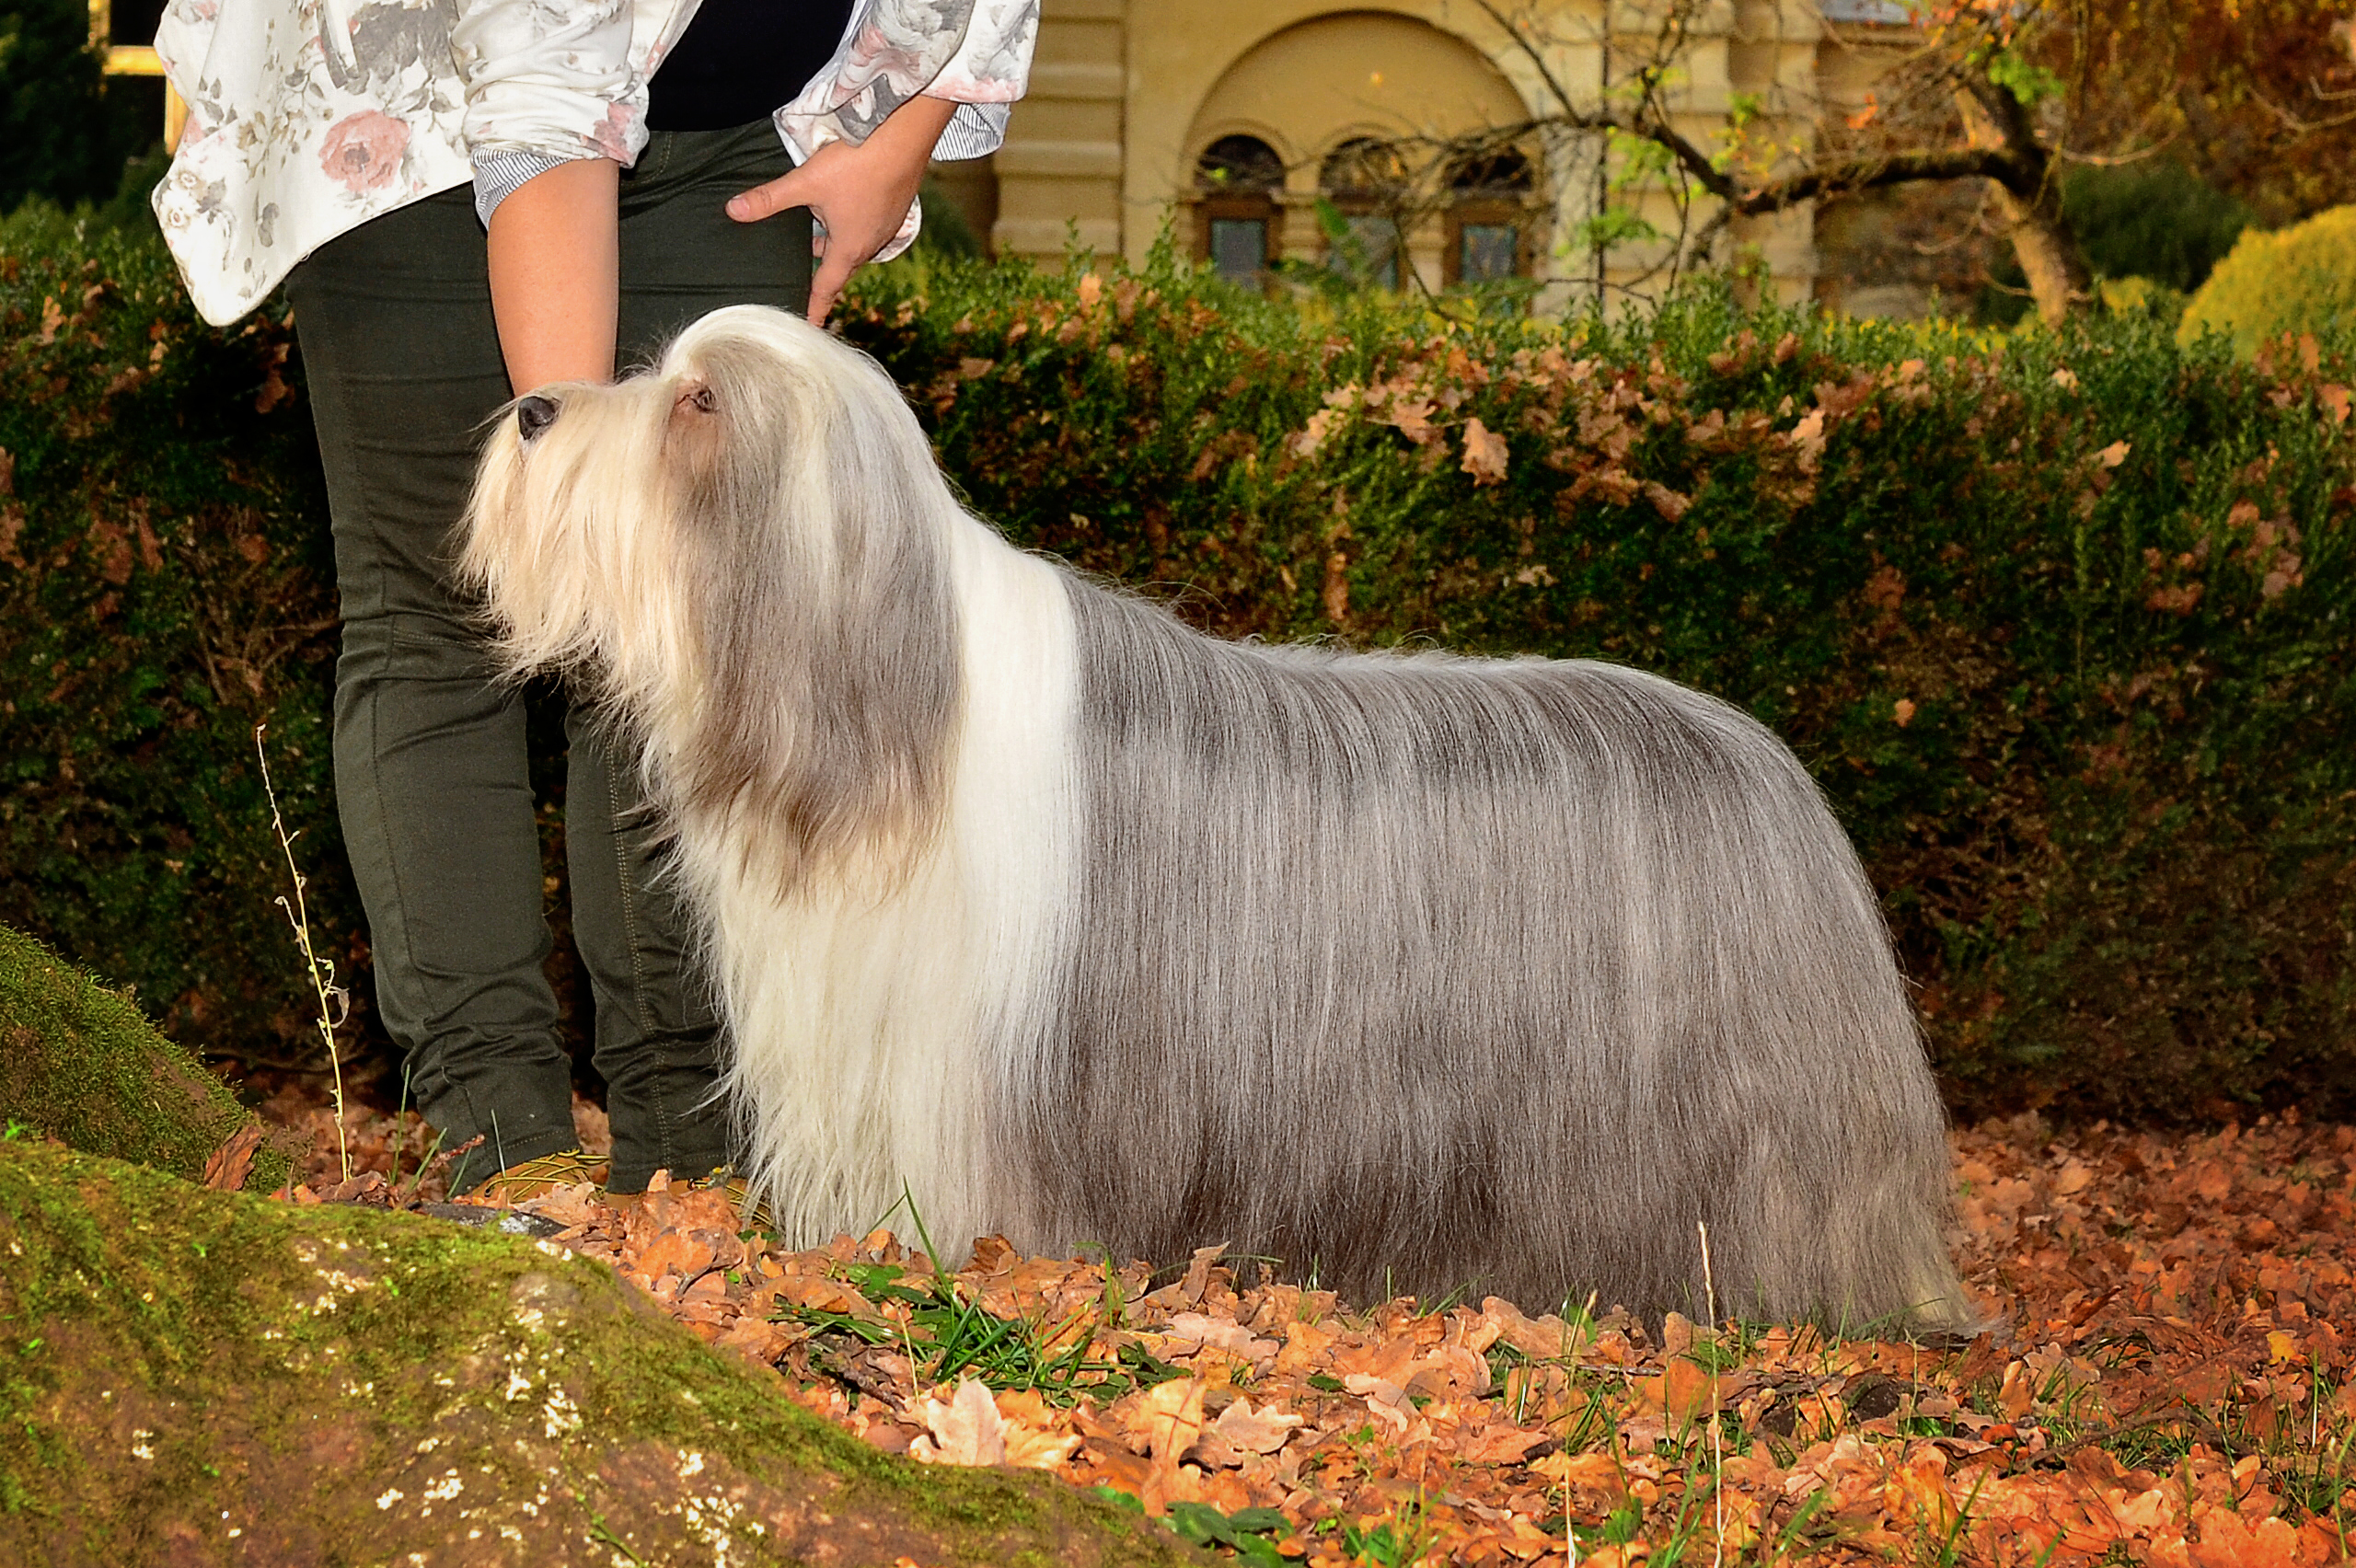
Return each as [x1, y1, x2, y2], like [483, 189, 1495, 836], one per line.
[942, 0, 1906, 304]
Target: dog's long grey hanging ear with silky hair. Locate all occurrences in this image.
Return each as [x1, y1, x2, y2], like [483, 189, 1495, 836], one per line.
[672, 327, 964, 878]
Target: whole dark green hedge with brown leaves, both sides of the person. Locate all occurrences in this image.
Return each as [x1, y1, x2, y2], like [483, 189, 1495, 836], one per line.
[0, 213, 2356, 1118]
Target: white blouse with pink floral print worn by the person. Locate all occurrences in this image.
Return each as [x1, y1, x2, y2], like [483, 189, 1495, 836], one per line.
[153, 0, 1039, 325]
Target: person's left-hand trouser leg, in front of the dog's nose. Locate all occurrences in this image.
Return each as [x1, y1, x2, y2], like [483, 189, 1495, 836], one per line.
[287, 190, 575, 1184]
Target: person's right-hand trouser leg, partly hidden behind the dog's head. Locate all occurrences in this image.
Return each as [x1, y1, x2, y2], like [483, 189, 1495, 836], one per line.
[565, 122, 811, 1192]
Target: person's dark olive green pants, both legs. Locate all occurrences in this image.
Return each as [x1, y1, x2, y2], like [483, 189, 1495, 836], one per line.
[287, 120, 811, 1192]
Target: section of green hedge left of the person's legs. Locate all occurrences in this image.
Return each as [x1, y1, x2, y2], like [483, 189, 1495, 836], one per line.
[0, 205, 343, 1057]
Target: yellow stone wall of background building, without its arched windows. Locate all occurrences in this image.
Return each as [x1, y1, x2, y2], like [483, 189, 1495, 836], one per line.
[961, 0, 1922, 310]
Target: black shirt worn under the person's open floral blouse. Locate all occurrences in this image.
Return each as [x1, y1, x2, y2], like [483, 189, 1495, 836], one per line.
[645, 0, 850, 130]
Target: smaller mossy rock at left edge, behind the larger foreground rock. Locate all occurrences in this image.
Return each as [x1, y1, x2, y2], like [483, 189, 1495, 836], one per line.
[0, 926, 297, 1192]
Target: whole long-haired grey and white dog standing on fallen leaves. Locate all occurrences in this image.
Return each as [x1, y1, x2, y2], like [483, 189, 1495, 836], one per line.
[464, 306, 1969, 1325]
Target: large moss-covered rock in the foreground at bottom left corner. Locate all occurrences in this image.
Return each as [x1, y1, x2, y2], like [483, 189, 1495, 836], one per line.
[0, 1137, 1202, 1568]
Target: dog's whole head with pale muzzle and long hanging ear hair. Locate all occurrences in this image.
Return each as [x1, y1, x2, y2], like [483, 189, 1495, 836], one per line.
[459, 306, 961, 870]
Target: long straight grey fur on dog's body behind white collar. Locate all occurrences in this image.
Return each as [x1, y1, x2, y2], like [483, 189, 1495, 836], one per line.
[1027, 577, 1969, 1328]
